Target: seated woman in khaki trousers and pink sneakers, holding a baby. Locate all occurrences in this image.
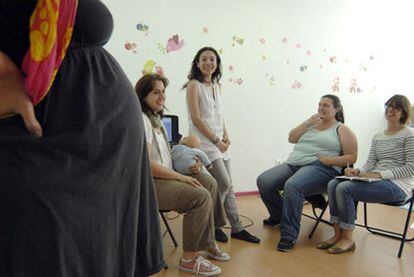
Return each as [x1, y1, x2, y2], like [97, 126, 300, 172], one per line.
[135, 74, 226, 276]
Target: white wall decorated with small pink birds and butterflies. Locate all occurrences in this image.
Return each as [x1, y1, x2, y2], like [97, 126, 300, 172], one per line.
[103, 0, 414, 191]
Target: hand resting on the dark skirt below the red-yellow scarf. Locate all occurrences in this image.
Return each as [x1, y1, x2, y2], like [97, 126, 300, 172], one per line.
[0, 52, 43, 137]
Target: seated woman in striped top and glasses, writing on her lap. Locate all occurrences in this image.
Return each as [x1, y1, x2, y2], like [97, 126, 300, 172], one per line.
[317, 94, 414, 254]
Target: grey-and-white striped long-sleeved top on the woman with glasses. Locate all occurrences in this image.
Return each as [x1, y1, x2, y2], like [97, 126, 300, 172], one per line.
[360, 127, 414, 195]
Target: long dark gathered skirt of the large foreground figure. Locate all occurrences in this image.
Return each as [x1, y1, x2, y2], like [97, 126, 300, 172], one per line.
[0, 47, 164, 277]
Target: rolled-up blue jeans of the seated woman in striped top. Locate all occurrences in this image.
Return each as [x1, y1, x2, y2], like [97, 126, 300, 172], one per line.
[328, 179, 407, 230]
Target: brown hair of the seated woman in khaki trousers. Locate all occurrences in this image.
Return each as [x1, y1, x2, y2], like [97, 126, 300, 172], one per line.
[135, 74, 169, 117]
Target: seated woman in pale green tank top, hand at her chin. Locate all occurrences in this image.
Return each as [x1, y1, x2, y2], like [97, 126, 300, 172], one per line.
[257, 94, 357, 252]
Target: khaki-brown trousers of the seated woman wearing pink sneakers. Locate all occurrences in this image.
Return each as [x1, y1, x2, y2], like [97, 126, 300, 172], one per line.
[154, 173, 225, 251]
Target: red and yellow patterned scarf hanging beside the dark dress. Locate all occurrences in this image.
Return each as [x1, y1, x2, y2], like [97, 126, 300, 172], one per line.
[22, 0, 78, 105]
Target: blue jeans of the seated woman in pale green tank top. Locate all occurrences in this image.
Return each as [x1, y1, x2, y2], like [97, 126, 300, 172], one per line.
[257, 160, 339, 240]
